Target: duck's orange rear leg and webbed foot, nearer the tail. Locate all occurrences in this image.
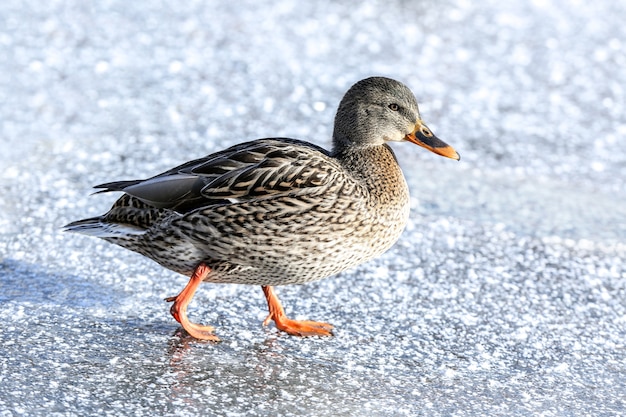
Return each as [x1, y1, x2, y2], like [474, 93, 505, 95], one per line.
[165, 264, 220, 342]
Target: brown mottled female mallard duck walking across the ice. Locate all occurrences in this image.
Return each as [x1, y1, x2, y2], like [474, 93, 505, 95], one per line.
[66, 77, 459, 340]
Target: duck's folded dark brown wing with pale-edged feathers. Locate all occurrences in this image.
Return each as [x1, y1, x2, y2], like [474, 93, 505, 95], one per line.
[95, 138, 342, 213]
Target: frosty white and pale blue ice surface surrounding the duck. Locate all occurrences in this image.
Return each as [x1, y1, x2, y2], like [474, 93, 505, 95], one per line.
[0, 0, 626, 417]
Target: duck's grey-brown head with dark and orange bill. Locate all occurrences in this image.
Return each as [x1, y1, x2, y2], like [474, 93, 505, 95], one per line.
[333, 77, 461, 160]
